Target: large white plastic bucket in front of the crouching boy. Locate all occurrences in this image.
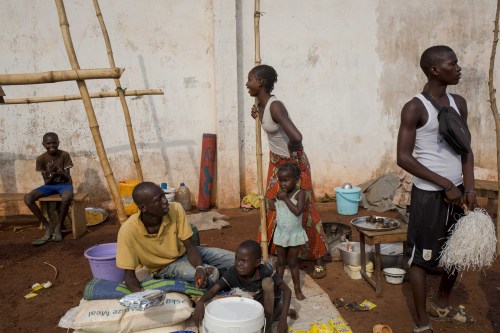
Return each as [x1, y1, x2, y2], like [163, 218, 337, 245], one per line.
[203, 297, 266, 333]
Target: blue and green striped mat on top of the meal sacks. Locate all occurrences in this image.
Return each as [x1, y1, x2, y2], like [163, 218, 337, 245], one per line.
[83, 279, 205, 301]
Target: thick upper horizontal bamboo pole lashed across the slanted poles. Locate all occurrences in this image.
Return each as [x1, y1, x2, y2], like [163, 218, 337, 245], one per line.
[0, 68, 125, 86]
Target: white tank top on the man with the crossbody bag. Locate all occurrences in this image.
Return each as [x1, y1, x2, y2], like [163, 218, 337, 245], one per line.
[413, 92, 462, 191]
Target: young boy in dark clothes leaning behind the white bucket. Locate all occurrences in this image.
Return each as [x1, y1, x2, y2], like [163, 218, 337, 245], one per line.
[193, 240, 292, 333]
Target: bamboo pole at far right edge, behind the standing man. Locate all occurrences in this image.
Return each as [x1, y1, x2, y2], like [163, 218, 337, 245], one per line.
[488, 0, 500, 254]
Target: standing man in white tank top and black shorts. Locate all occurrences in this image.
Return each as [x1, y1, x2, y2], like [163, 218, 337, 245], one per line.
[397, 45, 476, 333]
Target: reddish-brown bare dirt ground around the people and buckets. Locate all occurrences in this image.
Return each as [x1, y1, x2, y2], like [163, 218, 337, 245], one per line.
[0, 203, 500, 333]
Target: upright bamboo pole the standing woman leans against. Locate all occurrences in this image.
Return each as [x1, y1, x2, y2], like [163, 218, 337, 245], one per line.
[253, 0, 269, 260]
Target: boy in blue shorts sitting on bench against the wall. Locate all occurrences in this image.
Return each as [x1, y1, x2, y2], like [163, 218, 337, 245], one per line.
[24, 132, 73, 245]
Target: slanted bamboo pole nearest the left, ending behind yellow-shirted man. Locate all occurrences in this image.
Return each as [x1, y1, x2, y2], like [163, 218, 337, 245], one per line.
[55, 0, 127, 222]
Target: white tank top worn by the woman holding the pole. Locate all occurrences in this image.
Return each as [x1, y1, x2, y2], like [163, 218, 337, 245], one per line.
[262, 95, 290, 158]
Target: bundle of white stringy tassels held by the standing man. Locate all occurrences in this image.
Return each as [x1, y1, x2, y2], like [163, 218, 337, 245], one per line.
[440, 208, 497, 274]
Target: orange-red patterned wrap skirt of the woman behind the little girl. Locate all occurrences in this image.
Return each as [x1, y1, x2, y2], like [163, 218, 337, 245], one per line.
[257, 151, 327, 260]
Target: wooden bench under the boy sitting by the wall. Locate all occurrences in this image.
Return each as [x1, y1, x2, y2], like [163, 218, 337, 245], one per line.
[0, 192, 88, 239]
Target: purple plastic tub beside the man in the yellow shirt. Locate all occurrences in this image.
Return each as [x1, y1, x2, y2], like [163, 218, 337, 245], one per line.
[84, 243, 125, 282]
